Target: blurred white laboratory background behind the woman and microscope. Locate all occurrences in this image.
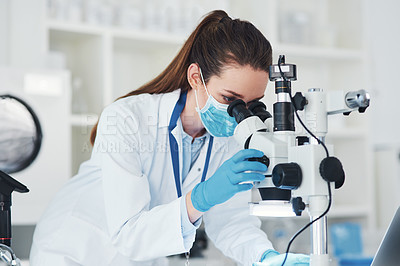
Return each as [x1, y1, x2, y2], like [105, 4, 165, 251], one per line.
[0, 0, 400, 265]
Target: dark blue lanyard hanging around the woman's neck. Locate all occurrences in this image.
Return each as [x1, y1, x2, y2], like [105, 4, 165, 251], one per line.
[168, 91, 214, 198]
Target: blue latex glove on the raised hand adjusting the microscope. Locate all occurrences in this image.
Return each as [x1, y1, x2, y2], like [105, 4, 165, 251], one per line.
[191, 149, 267, 212]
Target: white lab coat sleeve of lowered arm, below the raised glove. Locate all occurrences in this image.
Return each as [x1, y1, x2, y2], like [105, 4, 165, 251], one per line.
[203, 191, 273, 266]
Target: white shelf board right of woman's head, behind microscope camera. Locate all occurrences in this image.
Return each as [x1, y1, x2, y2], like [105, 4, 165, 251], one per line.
[274, 44, 364, 61]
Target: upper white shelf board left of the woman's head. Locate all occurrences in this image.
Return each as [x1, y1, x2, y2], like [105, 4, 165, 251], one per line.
[47, 20, 185, 45]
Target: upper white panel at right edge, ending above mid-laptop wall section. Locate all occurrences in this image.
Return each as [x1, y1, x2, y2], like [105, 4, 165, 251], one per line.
[366, 0, 400, 145]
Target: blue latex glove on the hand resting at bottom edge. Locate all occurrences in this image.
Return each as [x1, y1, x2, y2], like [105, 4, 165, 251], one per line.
[253, 249, 310, 266]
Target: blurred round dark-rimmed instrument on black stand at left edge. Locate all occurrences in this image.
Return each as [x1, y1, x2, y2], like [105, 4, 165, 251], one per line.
[0, 94, 42, 266]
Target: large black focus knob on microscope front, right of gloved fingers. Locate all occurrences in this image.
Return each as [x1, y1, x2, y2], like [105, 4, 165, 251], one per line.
[272, 163, 303, 190]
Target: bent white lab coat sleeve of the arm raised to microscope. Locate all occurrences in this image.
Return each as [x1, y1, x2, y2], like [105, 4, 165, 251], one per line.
[92, 101, 194, 261]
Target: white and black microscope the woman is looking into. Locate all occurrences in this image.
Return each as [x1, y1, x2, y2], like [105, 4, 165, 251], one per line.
[228, 55, 370, 266]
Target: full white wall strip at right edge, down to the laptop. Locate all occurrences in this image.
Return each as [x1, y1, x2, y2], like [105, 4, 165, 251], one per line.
[366, 0, 400, 230]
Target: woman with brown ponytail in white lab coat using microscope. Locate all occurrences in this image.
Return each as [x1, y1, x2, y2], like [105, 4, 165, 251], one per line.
[30, 11, 309, 266]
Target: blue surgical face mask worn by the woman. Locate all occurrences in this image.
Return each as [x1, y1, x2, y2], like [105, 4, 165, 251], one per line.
[194, 69, 237, 137]
